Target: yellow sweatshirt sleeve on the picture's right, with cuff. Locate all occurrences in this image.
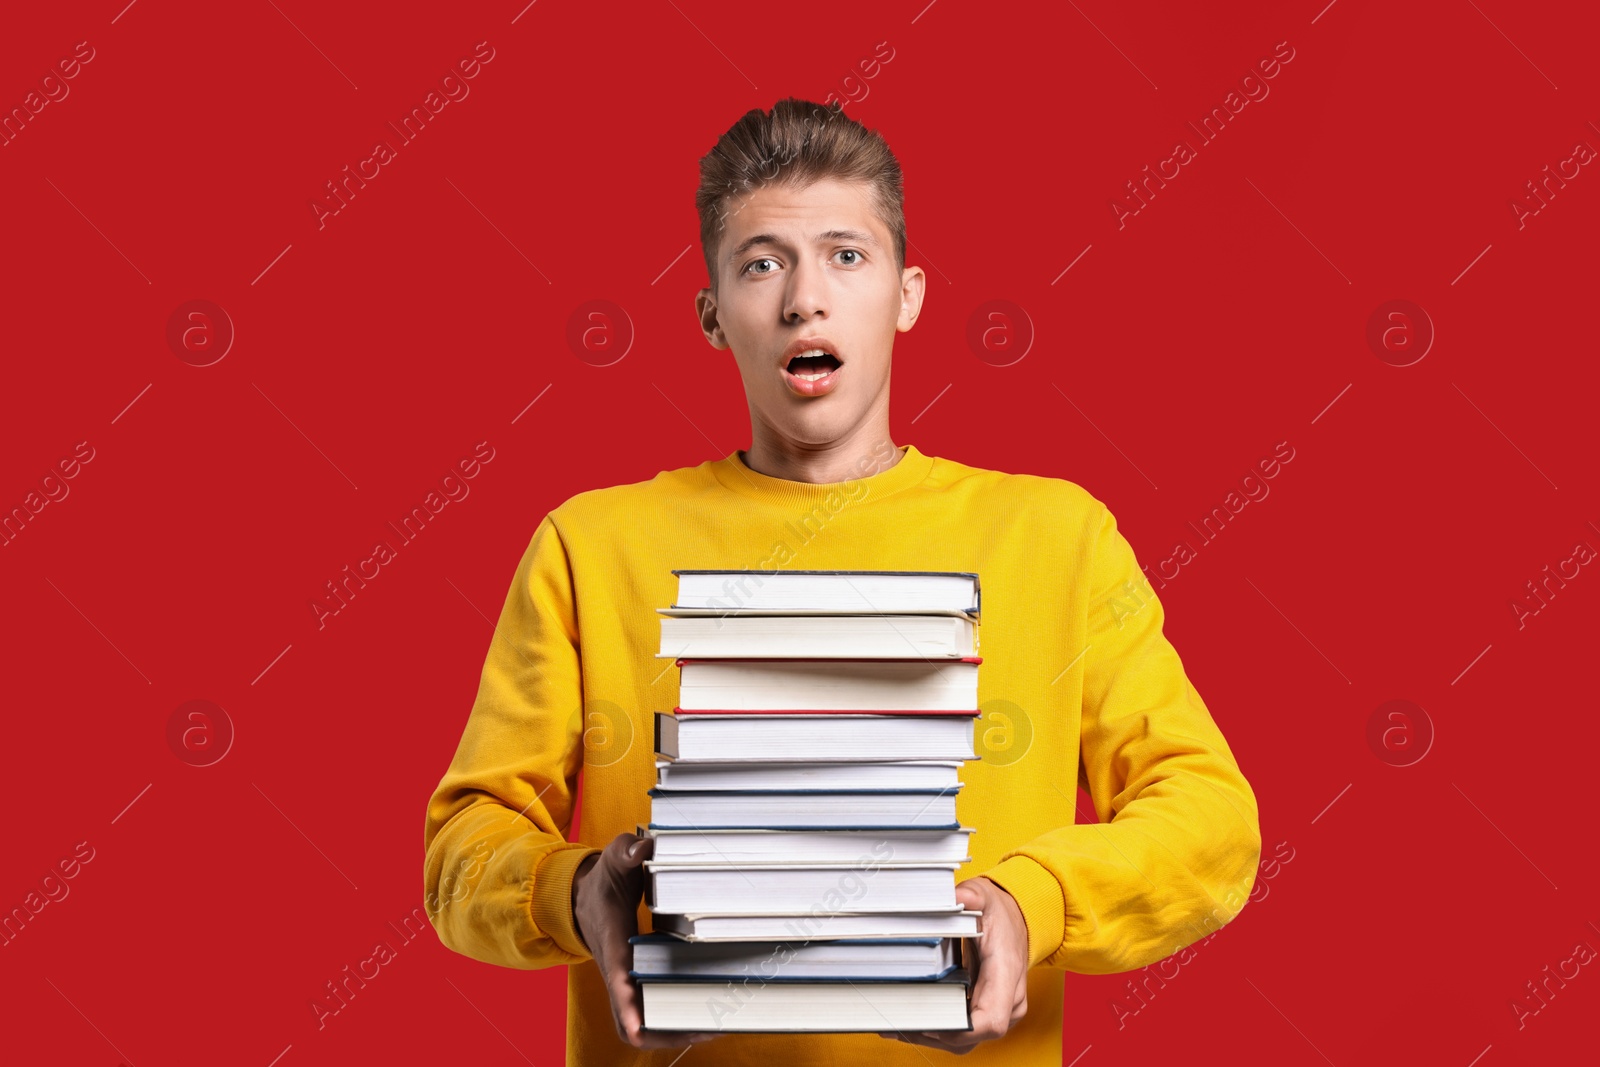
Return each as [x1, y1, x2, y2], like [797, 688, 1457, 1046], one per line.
[984, 506, 1261, 974]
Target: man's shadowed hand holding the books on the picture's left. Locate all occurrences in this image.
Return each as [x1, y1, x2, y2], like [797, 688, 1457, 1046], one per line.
[573, 833, 717, 1048]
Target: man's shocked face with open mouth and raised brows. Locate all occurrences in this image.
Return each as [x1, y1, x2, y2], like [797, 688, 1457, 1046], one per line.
[694, 179, 925, 448]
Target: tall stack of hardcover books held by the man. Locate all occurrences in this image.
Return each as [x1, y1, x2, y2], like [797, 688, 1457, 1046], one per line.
[629, 569, 981, 1033]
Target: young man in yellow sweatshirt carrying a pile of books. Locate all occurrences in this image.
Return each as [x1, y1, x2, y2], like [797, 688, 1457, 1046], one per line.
[424, 99, 1261, 1067]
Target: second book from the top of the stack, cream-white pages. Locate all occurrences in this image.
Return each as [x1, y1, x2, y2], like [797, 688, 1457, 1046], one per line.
[656, 614, 978, 659]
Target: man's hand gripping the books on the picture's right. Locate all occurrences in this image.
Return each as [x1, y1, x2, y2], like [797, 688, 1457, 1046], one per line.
[878, 877, 1027, 1056]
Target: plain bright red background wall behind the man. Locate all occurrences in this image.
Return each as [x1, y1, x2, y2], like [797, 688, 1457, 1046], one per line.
[0, 0, 1600, 1067]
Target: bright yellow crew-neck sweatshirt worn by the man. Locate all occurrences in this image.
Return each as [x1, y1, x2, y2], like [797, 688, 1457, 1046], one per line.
[424, 443, 1261, 1067]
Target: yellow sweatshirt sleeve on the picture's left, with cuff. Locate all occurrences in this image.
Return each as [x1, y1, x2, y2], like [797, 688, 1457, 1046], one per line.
[422, 515, 600, 968]
